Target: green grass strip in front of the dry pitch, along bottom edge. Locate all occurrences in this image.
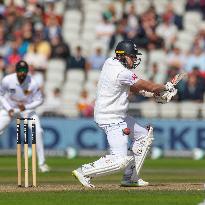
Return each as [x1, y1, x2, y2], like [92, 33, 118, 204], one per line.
[0, 191, 204, 205]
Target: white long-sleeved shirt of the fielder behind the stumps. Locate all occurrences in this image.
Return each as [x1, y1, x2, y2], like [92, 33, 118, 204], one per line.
[0, 73, 43, 111]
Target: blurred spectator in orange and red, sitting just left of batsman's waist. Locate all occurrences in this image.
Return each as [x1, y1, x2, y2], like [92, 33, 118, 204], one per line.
[77, 90, 94, 118]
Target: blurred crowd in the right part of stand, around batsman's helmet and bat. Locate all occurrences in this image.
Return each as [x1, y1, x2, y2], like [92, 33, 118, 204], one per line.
[96, 0, 205, 102]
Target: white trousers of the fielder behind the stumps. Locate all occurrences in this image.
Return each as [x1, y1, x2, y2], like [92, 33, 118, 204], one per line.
[0, 109, 45, 165]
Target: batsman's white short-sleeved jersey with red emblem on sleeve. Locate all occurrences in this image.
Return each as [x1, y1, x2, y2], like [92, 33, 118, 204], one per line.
[94, 58, 138, 124]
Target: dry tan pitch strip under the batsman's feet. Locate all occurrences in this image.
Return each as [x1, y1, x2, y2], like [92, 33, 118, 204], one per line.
[0, 183, 205, 192]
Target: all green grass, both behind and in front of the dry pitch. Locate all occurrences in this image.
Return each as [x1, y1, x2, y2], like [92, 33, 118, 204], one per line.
[0, 157, 205, 205]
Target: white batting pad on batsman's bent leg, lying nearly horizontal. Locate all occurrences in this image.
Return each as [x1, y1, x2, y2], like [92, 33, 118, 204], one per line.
[82, 155, 133, 177]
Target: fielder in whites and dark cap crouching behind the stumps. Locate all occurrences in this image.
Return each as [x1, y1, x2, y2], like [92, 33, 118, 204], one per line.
[0, 60, 50, 172]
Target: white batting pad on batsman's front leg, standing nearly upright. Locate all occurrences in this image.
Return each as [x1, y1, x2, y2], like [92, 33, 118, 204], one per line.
[132, 127, 154, 175]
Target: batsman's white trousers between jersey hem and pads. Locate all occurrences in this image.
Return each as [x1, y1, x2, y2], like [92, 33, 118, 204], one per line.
[99, 116, 148, 157]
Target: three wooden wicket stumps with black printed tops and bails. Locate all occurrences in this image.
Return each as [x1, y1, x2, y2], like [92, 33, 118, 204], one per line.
[16, 118, 36, 187]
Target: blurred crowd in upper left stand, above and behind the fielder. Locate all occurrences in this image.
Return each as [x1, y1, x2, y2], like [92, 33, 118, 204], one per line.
[0, 0, 64, 83]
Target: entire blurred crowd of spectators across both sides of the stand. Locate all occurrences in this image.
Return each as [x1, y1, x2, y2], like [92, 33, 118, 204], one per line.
[0, 0, 205, 117]
